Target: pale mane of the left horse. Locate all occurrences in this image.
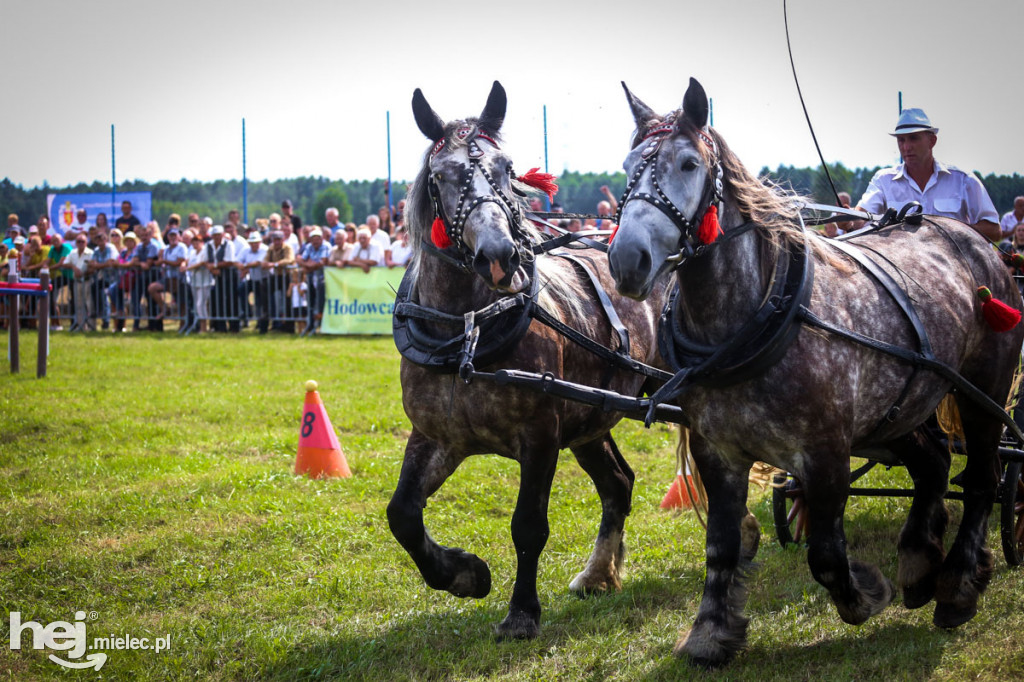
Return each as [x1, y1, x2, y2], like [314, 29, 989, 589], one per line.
[406, 118, 595, 334]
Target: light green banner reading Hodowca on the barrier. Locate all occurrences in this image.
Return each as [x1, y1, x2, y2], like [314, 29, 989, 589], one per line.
[321, 267, 406, 336]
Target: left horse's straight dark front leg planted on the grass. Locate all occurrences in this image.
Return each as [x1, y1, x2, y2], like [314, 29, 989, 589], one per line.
[495, 444, 558, 639]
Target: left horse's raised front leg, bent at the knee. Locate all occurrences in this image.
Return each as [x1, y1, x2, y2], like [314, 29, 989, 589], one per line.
[387, 428, 490, 599]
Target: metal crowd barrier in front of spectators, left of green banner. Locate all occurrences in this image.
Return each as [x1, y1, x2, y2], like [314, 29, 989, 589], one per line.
[7, 265, 311, 334]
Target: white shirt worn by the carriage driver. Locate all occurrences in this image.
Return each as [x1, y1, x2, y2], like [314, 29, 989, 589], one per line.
[857, 161, 999, 224]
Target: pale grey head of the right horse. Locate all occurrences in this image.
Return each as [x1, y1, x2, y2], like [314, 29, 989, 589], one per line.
[608, 78, 722, 300]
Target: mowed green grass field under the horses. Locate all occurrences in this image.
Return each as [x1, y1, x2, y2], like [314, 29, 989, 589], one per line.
[0, 332, 1024, 682]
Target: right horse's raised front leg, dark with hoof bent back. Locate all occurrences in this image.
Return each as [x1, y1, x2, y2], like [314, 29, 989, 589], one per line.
[802, 454, 896, 625]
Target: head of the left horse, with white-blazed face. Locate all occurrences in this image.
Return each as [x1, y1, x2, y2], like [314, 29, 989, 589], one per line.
[413, 81, 526, 291]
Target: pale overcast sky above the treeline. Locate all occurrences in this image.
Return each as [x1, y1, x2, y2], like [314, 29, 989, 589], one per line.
[0, 0, 1024, 191]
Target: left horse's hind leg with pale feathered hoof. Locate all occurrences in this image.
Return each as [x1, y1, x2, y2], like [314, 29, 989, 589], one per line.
[569, 433, 634, 596]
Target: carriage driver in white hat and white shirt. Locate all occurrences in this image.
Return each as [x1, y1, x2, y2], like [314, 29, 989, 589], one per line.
[857, 109, 1000, 242]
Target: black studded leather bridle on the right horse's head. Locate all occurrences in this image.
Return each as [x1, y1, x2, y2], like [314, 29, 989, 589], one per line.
[615, 123, 723, 269]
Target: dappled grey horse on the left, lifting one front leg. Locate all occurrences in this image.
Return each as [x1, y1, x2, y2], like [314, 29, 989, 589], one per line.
[387, 82, 664, 638]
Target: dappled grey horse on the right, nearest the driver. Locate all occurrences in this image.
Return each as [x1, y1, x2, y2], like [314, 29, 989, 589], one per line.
[608, 79, 1024, 666]
